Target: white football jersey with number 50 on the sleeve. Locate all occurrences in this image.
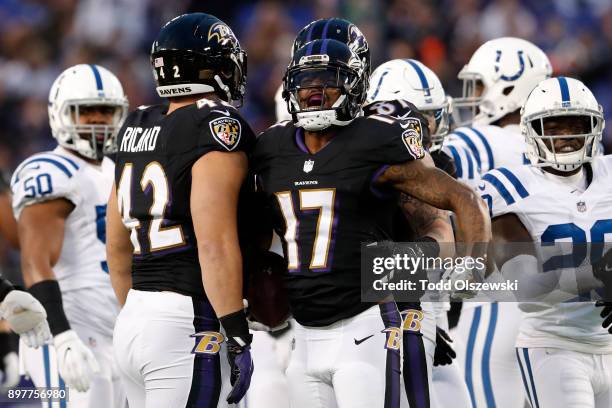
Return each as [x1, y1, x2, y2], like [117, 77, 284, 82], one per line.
[11, 146, 119, 335]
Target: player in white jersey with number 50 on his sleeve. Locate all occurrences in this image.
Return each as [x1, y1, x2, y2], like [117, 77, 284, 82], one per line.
[11, 64, 127, 407]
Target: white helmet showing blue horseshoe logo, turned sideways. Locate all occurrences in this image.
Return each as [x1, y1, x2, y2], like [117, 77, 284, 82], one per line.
[453, 37, 552, 126]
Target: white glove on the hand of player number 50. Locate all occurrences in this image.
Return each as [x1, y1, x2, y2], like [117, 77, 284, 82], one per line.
[53, 330, 100, 392]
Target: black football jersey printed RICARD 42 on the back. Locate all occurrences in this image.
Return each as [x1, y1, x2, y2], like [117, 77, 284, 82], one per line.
[115, 99, 255, 298]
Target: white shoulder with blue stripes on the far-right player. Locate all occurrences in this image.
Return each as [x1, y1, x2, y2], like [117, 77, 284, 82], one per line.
[478, 166, 529, 217]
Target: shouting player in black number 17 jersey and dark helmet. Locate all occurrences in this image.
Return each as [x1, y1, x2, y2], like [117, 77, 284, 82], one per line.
[253, 39, 489, 408]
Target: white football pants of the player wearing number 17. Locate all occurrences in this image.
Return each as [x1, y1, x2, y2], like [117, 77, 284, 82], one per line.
[287, 303, 401, 408]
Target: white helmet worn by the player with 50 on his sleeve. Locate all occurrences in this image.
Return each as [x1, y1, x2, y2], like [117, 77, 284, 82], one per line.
[49, 64, 128, 160]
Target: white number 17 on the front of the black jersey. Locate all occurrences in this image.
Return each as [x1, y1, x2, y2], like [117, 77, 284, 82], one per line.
[275, 188, 336, 272]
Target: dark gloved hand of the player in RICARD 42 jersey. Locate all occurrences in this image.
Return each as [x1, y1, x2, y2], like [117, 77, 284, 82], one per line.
[227, 334, 254, 404]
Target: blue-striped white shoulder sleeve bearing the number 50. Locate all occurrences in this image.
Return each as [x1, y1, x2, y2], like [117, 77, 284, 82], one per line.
[11, 152, 80, 218]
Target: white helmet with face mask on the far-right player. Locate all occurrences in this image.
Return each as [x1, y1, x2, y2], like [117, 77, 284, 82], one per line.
[521, 77, 605, 171]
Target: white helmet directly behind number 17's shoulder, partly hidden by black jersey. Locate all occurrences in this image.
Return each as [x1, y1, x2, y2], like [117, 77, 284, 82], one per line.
[366, 59, 452, 150]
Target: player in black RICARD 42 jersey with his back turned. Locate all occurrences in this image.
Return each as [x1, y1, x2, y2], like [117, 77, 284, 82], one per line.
[107, 13, 255, 408]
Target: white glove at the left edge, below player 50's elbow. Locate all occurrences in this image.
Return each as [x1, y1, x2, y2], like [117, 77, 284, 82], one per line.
[0, 290, 51, 348]
